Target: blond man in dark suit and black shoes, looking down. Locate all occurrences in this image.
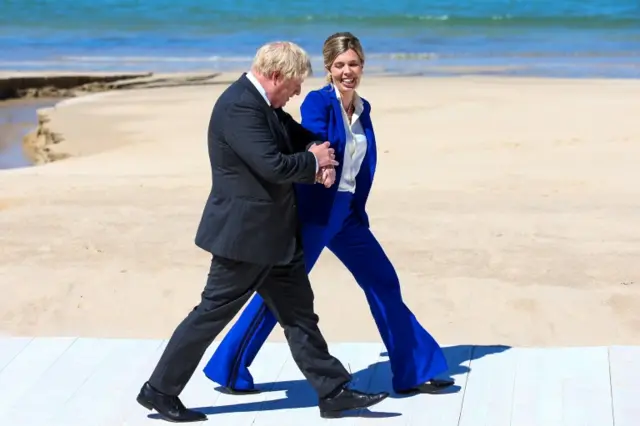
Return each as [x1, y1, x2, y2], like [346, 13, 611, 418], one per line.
[137, 42, 388, 422]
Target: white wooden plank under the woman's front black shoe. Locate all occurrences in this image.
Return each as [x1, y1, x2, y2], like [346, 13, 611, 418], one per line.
[357, 345, 472, 426]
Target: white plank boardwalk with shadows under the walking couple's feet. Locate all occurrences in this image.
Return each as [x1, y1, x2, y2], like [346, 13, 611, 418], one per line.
[0, 337, 640, 426]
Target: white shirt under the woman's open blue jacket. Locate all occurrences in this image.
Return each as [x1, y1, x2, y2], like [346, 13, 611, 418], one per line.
[335, 89, 367, 193]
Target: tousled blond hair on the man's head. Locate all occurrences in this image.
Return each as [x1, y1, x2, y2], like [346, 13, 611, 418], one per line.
[251, 41, 312, 80]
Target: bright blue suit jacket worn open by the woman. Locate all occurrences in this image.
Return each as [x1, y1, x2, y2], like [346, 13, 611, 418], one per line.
[295, 85, 376, 227]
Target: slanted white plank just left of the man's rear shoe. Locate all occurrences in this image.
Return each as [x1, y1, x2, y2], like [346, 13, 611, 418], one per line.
[54, 339, 166, 426]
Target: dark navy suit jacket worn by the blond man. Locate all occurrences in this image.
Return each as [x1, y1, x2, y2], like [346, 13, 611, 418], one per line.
[195, 74, 319, 265]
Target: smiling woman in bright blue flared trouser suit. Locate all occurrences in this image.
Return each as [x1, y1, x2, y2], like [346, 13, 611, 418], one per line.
[204, 33, 453, 394]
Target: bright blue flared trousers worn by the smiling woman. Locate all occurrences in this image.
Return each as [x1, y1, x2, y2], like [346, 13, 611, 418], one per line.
[204, 192, 448, 391]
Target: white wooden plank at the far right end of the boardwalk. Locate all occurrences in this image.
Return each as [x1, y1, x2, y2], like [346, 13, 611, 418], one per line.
[609, 346, 640, 426]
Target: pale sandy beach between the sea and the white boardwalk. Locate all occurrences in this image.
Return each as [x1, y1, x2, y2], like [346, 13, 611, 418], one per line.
[0, 74, 640, 346]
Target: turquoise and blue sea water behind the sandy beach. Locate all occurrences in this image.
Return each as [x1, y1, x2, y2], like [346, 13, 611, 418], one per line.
[0, 0, 640, 77]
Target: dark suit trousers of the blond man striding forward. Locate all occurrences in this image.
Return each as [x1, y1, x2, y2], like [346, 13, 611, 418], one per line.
[149, 248, 351, 398]
